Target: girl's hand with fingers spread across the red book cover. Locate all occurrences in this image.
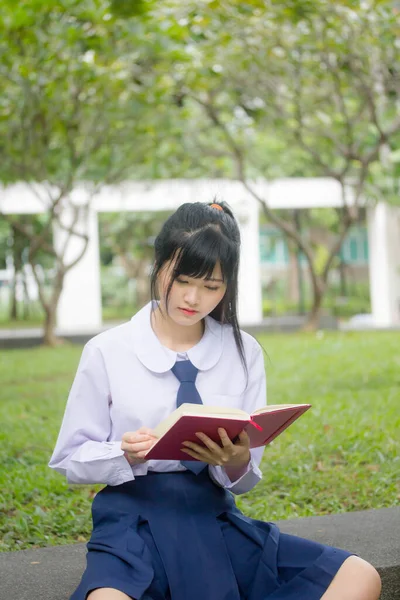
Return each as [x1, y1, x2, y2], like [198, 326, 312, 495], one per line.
[181, 429, 250, 469]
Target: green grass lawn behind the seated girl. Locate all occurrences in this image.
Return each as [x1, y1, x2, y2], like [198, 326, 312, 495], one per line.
[0, 332, 400, 551]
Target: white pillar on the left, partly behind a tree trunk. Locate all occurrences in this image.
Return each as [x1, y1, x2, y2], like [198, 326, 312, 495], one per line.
[54, 206, 102, 333]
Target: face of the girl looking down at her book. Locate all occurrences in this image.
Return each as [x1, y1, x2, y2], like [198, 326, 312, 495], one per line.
[158, 261, 226, 326]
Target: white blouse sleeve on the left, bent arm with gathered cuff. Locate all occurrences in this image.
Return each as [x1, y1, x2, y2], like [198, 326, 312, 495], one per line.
[49, 342, 148, 485]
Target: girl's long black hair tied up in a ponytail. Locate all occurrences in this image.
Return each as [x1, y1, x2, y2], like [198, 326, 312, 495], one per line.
[151, 202, 247, 373]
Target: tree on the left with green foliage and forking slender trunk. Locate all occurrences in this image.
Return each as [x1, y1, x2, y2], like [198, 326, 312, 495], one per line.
[0, 0, 159, 344]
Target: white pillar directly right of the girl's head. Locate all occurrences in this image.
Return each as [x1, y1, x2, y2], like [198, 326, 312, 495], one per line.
[234, 199, 262, 326]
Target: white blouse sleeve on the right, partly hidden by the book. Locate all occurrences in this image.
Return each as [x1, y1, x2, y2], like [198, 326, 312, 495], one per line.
[208, 340, 267, 495]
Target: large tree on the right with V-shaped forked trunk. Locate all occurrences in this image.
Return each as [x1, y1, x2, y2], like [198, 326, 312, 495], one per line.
[149, 0, 400, 328]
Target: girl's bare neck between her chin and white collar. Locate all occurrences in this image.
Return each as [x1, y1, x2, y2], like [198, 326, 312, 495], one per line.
[151, 308, 204, 352]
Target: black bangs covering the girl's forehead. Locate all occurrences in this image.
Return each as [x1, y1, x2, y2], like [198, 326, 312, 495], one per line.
[173, 227, 237, 283]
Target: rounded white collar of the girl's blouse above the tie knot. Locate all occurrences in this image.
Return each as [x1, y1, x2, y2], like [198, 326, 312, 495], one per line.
[131, 302, 224, 373]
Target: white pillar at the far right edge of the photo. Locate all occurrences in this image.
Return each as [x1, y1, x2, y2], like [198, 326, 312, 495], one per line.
[368, 202, 400, 327]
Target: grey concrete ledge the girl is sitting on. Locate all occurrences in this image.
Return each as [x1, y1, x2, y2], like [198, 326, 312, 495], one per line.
[0, 507, 400, 600]
